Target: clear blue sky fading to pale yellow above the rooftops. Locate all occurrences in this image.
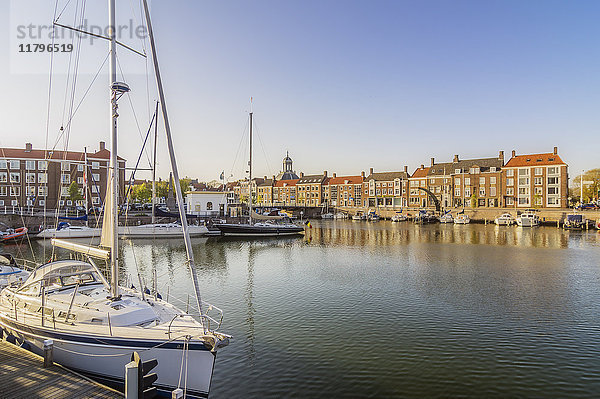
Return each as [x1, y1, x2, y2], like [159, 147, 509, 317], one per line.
[0, 0, 600, 180]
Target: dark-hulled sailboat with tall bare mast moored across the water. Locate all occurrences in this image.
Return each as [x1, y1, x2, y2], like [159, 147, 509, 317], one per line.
[215, 111, 304, 237]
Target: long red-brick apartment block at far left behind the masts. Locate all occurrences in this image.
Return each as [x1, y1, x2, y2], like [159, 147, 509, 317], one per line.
[0, 141, 125, 209]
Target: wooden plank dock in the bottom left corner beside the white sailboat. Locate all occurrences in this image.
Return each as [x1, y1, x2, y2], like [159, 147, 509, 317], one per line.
[0, 340, 125, 399]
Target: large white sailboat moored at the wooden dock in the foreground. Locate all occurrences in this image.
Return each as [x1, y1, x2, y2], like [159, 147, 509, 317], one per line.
[0, 0, 230, 398]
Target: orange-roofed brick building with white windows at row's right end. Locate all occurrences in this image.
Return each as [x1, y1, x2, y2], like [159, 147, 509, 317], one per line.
[502, 147, 569, 208]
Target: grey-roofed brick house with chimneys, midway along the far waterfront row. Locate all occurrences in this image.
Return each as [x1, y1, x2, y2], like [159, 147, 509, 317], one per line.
[363, 166, 409, 208]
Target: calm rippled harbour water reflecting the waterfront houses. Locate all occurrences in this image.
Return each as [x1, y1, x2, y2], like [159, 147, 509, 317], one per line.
[6, 221, 600, 399]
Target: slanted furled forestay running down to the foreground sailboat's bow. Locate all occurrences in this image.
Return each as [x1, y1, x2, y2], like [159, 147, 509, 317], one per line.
[141, 0, 202, 314]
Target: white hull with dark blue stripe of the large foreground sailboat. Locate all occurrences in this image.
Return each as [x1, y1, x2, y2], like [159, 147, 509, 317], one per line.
[0, 314, 216, 398]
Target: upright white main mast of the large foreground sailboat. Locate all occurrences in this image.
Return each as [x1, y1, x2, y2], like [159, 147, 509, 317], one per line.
[108, 0, 119, 298]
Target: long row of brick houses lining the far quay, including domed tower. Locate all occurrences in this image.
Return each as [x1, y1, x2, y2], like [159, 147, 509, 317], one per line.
[227, 147, 568, 208]
